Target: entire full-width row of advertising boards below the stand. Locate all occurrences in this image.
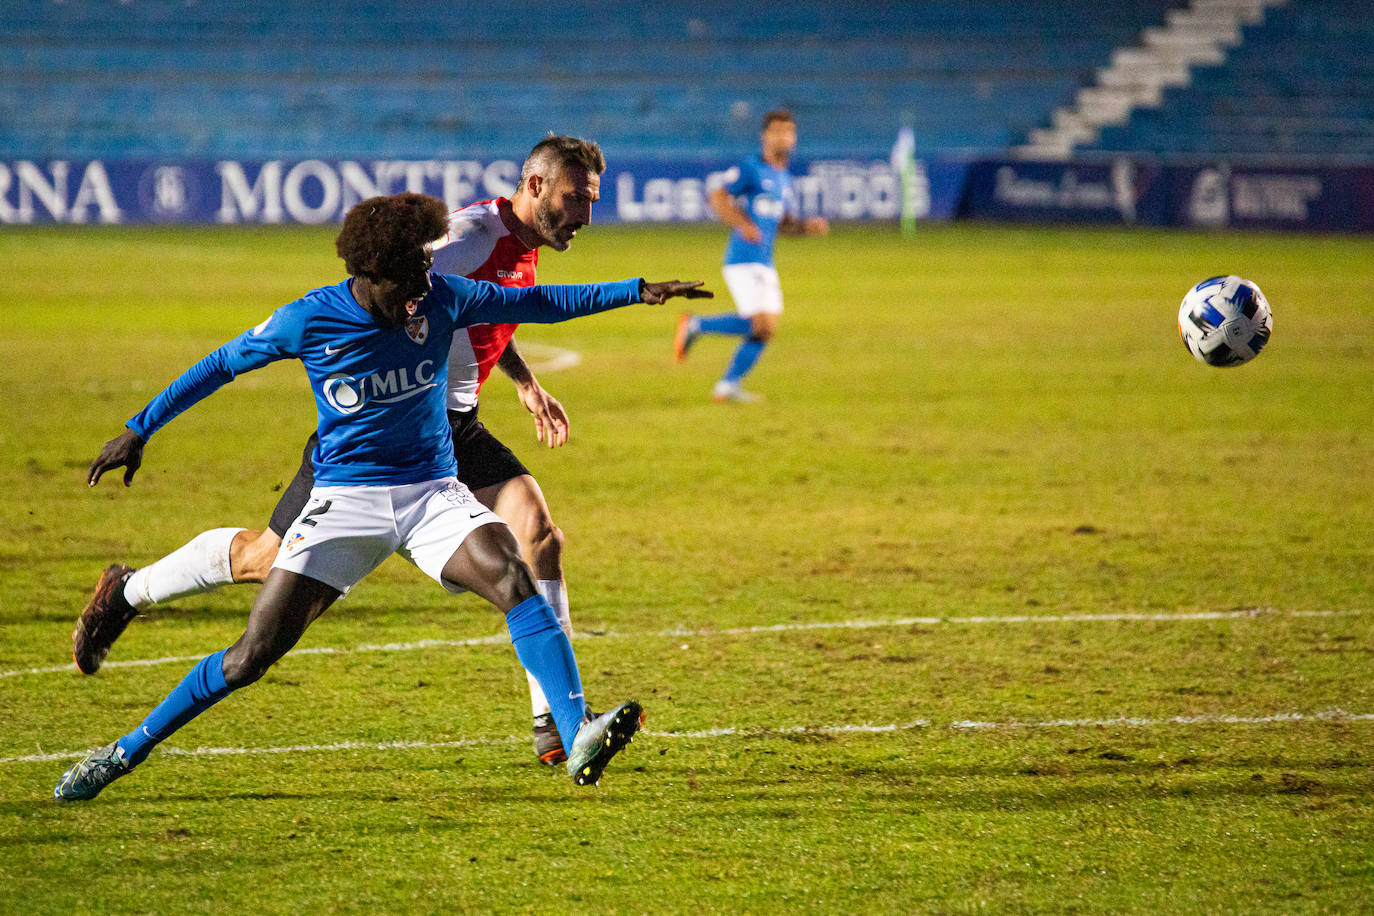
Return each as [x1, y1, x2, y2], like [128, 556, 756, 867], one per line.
[10, 157, 1374, 232]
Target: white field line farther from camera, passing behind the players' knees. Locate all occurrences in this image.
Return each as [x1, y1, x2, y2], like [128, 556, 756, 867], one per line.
[0, 608, 1364, 680]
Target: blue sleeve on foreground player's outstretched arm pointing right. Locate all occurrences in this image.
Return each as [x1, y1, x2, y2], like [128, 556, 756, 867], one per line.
[438, 275, 642, 327]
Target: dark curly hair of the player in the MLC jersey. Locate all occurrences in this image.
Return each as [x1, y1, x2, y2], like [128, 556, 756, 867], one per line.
[334, 194, 448, 279]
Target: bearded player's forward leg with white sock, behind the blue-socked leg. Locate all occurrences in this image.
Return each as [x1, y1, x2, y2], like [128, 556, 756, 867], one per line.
[473, 474, 573, 766]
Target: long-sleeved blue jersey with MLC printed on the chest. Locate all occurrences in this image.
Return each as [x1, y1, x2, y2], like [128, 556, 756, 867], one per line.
[126, 273, 640, 486]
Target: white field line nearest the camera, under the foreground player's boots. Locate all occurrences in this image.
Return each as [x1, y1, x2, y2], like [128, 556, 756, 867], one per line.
[0, 709, 1374, 764]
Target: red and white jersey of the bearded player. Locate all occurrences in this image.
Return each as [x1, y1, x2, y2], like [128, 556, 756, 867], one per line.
[434, 198, 539, 411]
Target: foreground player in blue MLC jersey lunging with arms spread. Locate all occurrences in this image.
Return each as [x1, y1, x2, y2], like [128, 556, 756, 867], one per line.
[54, 194, 709, 801]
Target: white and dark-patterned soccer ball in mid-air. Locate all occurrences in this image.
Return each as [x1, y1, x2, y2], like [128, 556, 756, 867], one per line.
[1179, 276, 1274, 365]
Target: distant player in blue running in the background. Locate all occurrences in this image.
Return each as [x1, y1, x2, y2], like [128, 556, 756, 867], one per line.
[673, 110, 830, 402]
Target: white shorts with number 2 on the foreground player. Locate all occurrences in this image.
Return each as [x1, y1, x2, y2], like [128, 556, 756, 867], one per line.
[272, 477, 506, 593]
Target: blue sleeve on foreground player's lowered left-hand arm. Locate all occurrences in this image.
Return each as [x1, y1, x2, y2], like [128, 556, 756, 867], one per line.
[125, 302, 305, 442]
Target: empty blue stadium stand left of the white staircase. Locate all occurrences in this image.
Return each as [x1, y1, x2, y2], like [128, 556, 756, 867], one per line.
[0, 0, 1181, 158]
